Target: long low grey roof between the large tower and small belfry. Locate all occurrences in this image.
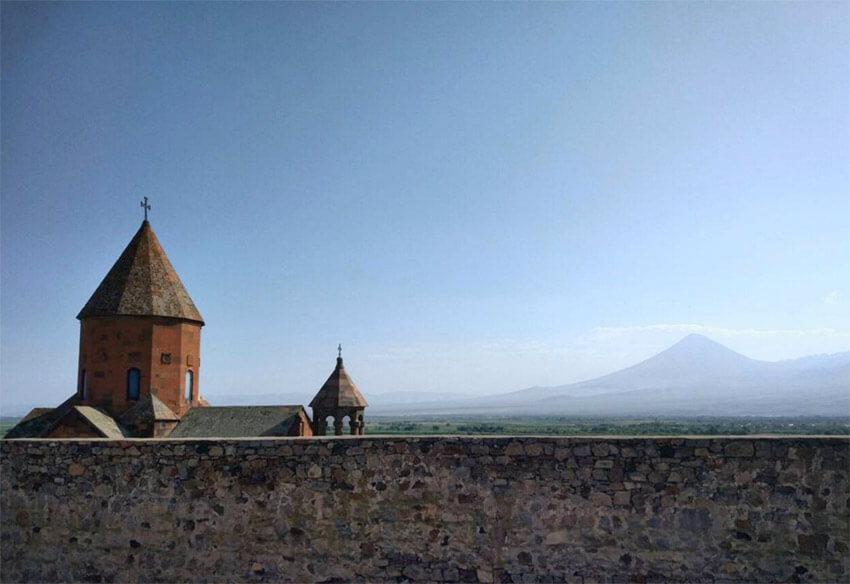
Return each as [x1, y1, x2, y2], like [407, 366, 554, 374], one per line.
[168, 406, 310, 438]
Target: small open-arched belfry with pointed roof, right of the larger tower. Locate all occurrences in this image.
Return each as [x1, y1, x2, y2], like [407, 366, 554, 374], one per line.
[310, 345, 369, 436]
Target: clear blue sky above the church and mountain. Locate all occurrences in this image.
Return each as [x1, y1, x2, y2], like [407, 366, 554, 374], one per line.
[0, 2, 850, 413]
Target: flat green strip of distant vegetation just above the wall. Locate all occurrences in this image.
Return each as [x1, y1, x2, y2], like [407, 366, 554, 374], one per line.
[366, 416, 850, 436]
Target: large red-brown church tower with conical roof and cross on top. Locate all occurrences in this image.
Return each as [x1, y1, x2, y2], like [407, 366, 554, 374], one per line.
[77, 203, 204, 416]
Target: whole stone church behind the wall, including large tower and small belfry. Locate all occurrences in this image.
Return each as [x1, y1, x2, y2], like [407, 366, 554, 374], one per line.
[5, 214, 368, 438]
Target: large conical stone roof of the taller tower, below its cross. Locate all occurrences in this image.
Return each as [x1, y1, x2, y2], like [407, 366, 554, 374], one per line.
[77, 221, 204, 325]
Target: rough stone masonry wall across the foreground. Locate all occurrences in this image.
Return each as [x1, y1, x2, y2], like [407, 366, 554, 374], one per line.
[0, 437, 850, 582]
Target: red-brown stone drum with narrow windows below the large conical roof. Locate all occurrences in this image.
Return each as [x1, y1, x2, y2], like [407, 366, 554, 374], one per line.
[78, 316, 201, 415]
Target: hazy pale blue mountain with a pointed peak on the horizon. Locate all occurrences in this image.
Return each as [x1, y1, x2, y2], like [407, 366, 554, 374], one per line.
[380, 335, 850, 416]
